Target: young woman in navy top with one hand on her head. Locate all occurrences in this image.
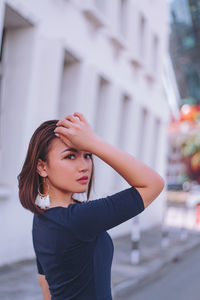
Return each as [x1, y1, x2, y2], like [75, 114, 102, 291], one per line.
[18, 113, 164, 300]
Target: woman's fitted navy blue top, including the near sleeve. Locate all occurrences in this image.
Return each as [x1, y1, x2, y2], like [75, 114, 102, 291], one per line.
[32, 187, 144, 300]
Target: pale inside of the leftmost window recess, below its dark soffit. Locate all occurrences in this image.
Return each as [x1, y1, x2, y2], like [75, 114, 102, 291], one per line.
[0, 28, 37, 188]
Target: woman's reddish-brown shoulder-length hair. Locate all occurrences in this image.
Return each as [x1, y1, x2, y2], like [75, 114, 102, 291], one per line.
[17, 120, 94, 215]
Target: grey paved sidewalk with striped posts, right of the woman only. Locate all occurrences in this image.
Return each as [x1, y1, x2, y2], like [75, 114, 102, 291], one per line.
[112, 226, 200, 299]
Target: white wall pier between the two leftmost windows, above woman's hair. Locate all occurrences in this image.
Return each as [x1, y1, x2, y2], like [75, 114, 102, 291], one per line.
[22, 38, 64, 165]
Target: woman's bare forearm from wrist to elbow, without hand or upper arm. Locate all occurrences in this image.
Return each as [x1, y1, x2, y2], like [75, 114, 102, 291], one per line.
[90, 137, 164, 187]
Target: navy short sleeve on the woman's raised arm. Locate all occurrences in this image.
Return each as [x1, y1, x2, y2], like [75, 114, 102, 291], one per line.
[67, 187, 145, 241]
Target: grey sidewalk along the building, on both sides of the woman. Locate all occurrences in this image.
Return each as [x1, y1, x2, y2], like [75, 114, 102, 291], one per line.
[0, 226, 200, 300]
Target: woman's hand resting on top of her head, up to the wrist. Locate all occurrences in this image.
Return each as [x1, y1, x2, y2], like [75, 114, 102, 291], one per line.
[54, 112, 98, 151]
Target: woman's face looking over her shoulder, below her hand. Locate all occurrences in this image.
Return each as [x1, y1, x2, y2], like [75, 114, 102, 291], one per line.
[43, 138, 93, 193]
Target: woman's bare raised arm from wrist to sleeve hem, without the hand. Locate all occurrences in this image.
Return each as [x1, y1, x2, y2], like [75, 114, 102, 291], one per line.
[90, 137, 165, 208]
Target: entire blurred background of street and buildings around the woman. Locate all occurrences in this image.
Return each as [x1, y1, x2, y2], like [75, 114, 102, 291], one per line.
[0, 0, 200, 300]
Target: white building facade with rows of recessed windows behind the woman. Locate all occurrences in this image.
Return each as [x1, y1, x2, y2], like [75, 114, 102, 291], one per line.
[0, 0, 170, 266]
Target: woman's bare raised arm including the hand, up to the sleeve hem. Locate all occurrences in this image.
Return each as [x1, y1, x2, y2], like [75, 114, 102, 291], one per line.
[54, 112, 165, 208]
